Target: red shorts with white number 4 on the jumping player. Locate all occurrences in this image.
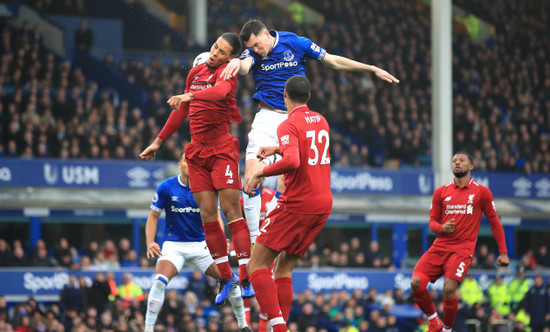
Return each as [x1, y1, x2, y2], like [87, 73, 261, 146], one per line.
[185, 136, 242, 192]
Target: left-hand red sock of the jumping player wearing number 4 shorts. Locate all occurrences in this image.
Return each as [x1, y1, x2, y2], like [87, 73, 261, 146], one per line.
[203, 220, 233, 279]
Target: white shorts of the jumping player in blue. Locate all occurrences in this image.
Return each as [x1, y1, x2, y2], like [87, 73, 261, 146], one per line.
[245, 108, 288, 160]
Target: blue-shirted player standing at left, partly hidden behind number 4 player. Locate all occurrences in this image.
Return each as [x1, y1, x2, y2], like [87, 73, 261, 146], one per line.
[145, 154, 252, 332]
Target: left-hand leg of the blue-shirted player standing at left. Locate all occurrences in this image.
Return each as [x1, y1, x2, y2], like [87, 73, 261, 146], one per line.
[145, 241, 185, 332]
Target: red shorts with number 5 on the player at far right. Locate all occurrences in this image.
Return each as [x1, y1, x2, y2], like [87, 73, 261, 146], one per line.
[413, 248, 472, 284]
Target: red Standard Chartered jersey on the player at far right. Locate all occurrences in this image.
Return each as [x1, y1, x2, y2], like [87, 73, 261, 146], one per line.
[430, 179, 506, 254]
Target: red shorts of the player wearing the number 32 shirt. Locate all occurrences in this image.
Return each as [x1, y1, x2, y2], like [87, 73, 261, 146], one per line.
[256, 208, 329, 256]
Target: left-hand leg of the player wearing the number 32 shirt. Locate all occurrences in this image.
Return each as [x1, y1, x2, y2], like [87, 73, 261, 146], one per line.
[247, 242, 287, 332]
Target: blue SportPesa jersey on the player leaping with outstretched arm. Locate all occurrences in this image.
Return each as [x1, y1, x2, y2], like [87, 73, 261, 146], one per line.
[241, 31, 327, 111]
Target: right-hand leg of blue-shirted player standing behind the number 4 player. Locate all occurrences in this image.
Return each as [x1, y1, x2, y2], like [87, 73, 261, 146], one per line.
[189, 242, 251, 332]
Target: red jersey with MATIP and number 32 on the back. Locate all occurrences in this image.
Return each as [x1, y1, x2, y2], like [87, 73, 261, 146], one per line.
[271, 105, 332, 214]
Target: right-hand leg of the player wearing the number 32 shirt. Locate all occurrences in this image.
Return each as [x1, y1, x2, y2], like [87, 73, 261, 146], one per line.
[273, 251, 300, 321]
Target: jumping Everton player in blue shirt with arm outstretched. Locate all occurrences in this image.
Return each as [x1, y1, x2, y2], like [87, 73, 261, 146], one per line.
[222, 20, 399, 254]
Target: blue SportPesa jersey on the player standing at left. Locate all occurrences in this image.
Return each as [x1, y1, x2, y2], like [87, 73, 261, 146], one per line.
[151, 175, 204, 242]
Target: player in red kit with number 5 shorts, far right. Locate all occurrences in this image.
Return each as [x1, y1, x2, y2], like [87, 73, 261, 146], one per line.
[411, 151, 510, 332]
